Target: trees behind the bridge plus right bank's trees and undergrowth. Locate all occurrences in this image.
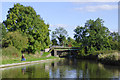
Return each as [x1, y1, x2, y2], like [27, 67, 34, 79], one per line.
[52, 18, 120, 64]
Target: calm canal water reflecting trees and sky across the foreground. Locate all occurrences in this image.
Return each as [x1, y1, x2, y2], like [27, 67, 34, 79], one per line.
[0, 59, 120, 79]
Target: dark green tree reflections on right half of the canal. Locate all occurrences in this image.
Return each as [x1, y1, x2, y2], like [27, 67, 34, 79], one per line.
[50, 59, 120, 78]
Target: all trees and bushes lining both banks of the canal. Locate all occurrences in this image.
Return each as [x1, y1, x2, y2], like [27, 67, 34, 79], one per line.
[0, 3, 120, 63]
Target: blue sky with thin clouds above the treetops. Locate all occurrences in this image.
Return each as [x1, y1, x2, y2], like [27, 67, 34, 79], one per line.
[0, 2, 118, 38]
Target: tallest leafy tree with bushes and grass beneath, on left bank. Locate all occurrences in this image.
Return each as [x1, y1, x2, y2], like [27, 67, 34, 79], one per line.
[0, 3, 53, 64]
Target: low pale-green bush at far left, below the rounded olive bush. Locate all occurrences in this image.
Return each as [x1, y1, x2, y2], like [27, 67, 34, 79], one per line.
[2, 46, 20, 56]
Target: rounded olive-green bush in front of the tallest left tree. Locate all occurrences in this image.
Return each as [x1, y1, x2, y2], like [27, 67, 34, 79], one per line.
[2, 31, 28, 51]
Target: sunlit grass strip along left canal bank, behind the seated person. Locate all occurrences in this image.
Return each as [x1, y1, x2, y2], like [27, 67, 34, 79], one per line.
[2, 53, 57, 64]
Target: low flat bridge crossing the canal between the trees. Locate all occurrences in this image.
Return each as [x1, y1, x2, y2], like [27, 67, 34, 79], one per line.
[49, 46, 80, 57]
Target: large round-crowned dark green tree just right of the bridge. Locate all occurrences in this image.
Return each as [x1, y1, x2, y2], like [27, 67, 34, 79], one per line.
[74, 18, 111, 53]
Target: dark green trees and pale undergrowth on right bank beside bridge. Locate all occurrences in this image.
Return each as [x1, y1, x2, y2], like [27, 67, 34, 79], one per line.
[74, 18, 120, 64]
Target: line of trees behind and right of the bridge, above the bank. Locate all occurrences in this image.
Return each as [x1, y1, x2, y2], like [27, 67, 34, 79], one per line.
[52, 18, 120, 55]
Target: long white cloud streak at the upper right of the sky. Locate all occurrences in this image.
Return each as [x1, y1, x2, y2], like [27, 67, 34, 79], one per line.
[75, 5, 118, 12]
